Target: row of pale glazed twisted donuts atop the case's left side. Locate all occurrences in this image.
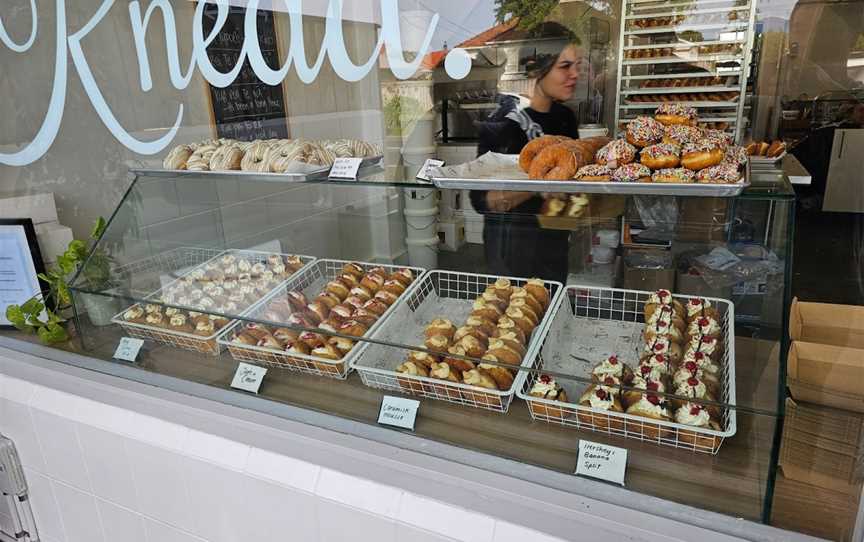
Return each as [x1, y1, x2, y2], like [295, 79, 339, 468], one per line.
[162, 138, 381, 173]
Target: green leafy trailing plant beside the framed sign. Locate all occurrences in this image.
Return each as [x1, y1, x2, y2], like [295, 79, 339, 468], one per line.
[6, 217, 114, 344]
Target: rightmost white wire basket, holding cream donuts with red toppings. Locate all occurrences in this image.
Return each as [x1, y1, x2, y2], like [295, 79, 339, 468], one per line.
[517, 286, 736, 454]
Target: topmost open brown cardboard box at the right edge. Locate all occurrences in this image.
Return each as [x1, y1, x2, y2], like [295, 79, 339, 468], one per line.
[789, 298, 864, 349]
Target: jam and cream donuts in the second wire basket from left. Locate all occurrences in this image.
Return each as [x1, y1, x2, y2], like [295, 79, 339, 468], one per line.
[232, 263, 416, 372]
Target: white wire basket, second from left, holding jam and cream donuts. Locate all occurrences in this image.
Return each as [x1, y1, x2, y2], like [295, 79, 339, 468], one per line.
[218, 260, 426, 380]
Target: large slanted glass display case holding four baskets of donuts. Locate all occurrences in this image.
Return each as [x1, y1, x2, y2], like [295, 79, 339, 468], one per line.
[72, 164, 794, 521]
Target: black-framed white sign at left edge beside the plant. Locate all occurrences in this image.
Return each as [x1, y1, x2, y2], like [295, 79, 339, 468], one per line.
[0, 218, 45, 327]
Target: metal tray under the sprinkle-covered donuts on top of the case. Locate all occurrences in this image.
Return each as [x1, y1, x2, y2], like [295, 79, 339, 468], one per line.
[432, 168, 750, 198]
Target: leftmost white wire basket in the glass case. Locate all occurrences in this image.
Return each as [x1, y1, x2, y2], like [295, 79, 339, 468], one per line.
[111, 248, 315, 356]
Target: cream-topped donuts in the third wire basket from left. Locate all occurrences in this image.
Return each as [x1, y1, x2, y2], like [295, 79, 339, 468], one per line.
[396, 278, 550, 399]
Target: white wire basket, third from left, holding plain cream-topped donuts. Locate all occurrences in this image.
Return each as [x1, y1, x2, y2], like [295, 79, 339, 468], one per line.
[352, 269, 563, 412]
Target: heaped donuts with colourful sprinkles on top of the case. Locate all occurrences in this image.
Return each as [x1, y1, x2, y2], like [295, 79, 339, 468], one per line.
[574, 104, 748, 184]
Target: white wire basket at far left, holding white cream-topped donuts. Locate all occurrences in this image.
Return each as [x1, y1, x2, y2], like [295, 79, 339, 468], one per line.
[111, 249, 315, 356]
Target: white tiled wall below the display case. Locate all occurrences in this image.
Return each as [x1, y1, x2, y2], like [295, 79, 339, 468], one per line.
[0, 374, 559, 542]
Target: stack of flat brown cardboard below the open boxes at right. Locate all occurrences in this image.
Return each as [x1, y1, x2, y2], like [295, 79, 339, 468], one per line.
[780, 399, 864, 493]
